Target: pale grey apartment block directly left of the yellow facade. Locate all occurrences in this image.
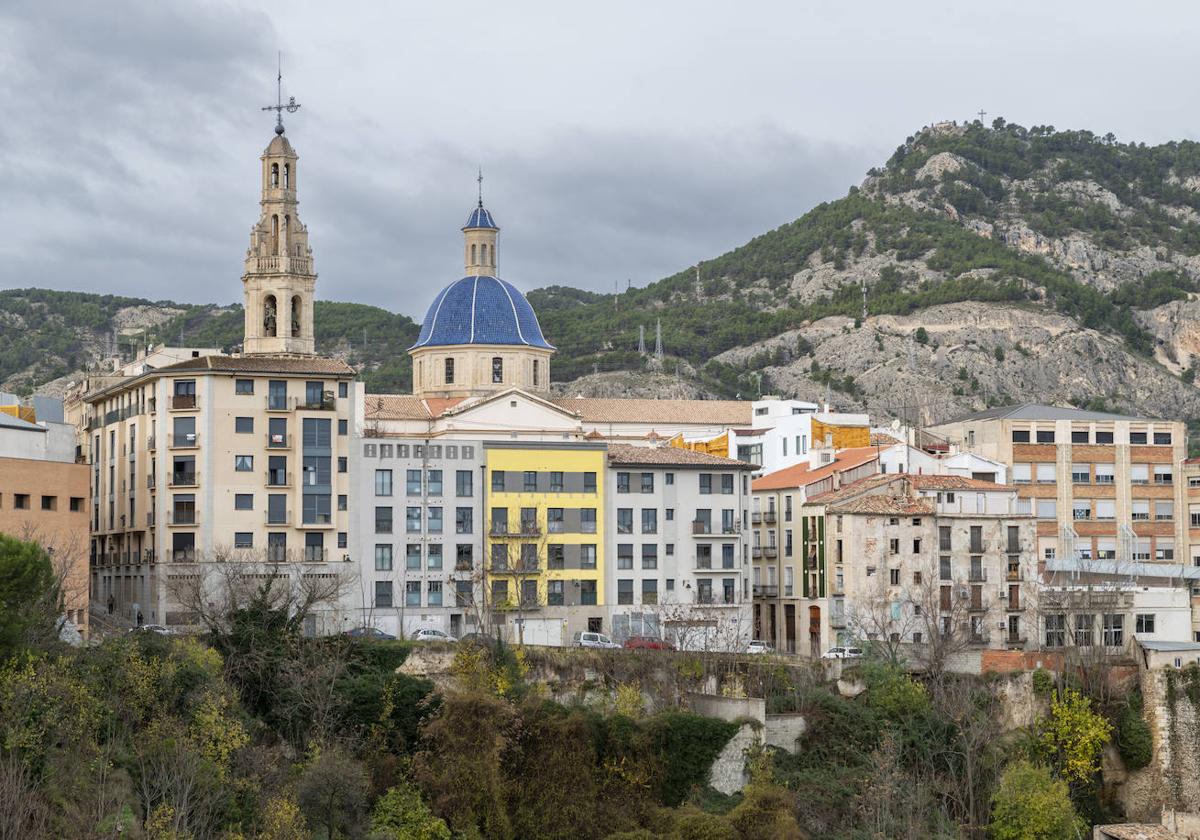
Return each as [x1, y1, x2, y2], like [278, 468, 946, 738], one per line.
[347, 434, 487, 638]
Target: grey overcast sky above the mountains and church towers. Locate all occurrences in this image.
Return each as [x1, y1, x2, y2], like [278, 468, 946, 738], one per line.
[0, 0, 1200, 319]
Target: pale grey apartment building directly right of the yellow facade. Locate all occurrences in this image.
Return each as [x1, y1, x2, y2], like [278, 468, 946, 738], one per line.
[605, 444, 752, 650]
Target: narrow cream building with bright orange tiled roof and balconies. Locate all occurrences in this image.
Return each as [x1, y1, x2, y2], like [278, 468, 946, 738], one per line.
[750, 446, 880, 653]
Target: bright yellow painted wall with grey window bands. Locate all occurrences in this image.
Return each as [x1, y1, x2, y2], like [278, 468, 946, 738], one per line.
[484, 446, 607, 606]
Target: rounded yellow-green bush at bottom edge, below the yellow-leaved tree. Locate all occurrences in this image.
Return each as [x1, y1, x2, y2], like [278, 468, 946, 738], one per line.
[991, 760, 1087, 840]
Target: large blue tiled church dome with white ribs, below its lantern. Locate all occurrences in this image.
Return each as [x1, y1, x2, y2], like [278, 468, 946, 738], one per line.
[409, 277, 554, 350]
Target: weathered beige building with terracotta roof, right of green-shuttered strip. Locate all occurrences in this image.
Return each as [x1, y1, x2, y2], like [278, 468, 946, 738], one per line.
[799, 475, 1038, 659]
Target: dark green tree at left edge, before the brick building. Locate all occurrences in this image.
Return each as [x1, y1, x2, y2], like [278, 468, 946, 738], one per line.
[0, 534, 62, 661]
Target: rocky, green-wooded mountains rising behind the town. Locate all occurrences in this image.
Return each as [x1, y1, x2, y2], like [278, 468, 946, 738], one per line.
[7, 120, 1200, 436]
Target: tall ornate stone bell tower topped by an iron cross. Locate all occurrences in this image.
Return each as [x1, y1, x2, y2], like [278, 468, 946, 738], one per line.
[241, 85, 317, 355]
